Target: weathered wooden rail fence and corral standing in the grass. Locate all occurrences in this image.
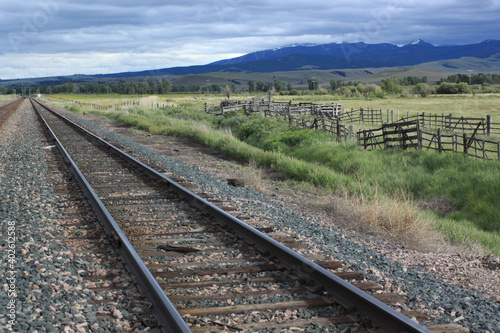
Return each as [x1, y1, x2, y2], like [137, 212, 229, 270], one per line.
[205, 98, 500, 161]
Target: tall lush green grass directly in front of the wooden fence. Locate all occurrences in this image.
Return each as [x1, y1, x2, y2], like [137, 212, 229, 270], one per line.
[220, 111, 500, 253]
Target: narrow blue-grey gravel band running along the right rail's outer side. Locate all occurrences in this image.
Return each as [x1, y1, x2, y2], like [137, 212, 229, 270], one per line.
[51, 105, 500, 332]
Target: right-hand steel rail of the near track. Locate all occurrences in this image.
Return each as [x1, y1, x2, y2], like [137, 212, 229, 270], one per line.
[31, 98, 431, 333]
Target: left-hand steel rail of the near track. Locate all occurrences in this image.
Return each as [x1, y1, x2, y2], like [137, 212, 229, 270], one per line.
[30, 99, 191, 333]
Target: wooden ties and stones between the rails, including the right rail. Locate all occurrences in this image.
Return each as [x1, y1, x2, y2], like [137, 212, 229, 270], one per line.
[33, 97, 428, 332]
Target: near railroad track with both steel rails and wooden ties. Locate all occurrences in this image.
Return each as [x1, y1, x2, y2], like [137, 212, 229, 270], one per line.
[31, 100, 452, 332]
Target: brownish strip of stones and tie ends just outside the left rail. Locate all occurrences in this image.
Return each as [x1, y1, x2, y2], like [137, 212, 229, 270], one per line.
[36, 104, 161, 332]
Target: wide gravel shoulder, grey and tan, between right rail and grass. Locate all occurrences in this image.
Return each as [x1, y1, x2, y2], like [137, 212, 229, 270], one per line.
[65, 109, 500, 332]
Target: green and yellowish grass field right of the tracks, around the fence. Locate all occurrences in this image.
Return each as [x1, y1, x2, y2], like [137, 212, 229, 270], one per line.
[47, 95, 500, 254]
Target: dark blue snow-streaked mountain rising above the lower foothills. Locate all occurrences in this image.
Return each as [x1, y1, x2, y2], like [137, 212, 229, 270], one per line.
[209, 39, 500, 72]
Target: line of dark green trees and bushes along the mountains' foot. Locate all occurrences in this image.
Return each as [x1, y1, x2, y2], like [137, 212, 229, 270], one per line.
[0, 73, 500, 98]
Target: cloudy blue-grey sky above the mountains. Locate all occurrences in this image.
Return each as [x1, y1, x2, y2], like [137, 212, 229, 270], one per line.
[0, 0, 500, 79]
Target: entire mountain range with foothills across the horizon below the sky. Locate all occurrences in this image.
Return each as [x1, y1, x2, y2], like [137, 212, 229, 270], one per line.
[0, 39, 500, 86]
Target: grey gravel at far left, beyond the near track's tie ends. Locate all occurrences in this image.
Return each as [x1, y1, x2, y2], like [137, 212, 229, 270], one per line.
[0, 102, 156, 332]
